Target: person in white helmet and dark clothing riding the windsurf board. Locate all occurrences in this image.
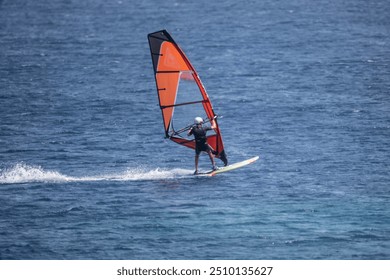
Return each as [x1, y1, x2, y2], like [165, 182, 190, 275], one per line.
[188, 117, 217, 175]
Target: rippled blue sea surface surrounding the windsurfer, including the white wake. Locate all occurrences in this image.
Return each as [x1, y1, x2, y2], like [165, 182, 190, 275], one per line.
[0, 0, 390, 260]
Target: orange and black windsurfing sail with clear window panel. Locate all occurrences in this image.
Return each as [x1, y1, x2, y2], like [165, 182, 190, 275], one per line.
[148, 30, 227, 165]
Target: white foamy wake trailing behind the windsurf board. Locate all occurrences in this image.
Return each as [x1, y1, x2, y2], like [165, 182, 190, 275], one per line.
[0, 163, 191, 184]
